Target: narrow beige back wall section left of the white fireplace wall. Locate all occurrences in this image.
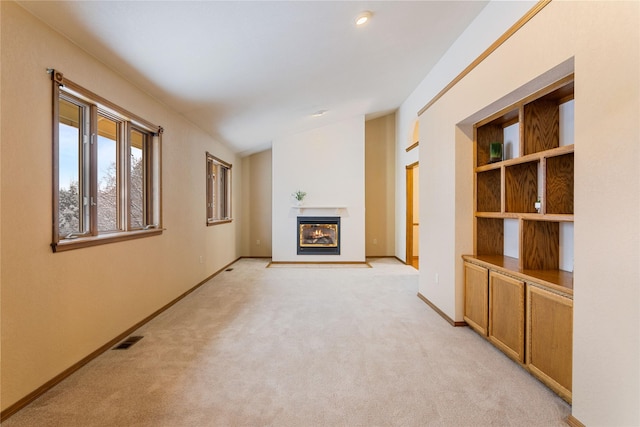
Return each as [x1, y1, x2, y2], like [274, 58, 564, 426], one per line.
[242, 150, 272, 257]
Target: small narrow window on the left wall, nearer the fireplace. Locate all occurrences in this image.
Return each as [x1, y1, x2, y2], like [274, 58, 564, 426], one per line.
[207, 153, 232, 225]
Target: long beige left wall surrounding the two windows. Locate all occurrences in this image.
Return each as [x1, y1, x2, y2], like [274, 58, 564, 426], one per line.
[0, 1, 242, 409]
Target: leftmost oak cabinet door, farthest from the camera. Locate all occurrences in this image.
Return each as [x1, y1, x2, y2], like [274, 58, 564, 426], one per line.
[464, 262, 489, 336]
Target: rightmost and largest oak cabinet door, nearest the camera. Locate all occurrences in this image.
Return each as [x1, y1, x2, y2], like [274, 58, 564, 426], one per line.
[527, 285, 573, 403]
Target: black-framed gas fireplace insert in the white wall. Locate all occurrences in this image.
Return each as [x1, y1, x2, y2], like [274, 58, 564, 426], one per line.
[297, 216, 340, 255]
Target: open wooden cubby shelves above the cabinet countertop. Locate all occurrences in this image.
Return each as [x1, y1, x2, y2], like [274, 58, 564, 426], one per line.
[474, 76, 574, 278]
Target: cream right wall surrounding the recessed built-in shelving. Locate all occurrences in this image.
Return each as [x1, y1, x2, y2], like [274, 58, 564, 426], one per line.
[420, 1, 640, 425]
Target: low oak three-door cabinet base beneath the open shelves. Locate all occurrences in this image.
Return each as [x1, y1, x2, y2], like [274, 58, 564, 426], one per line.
[463, 255, 573, 403]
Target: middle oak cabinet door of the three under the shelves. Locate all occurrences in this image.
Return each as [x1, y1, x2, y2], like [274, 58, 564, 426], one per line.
[489, 271, 525, 363]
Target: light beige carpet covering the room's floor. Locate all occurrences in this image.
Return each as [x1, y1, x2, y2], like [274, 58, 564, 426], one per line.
[3, 258, 570, 427]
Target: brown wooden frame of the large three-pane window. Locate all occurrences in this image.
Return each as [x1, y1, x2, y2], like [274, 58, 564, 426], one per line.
[49, 69, 164, 252]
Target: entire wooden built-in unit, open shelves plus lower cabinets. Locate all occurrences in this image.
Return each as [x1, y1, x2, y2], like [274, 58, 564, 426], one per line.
[463, 75, 575, 402]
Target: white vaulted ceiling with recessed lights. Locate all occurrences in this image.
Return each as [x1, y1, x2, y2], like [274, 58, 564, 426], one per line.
[19, 1, 487, 154]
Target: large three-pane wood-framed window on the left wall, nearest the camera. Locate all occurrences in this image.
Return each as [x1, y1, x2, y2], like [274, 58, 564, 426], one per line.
[51, 70, 162, 252]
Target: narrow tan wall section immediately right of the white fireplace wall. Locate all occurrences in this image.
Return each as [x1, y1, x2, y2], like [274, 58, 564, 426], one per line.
[364, 113, 396, 256]
